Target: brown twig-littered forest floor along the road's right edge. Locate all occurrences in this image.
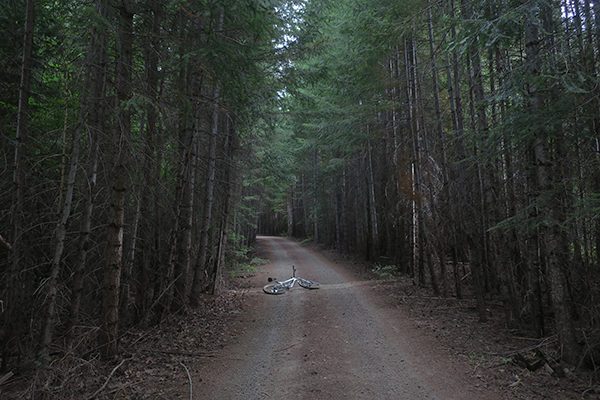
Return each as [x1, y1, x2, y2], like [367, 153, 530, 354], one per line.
[375, 281, 600, 399]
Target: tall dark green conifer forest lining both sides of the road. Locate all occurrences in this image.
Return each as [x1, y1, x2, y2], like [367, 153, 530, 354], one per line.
[0, 0, 600, 390]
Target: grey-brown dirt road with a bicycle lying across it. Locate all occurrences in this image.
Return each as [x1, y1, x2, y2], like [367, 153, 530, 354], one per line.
[194, 237, 482, 400]
